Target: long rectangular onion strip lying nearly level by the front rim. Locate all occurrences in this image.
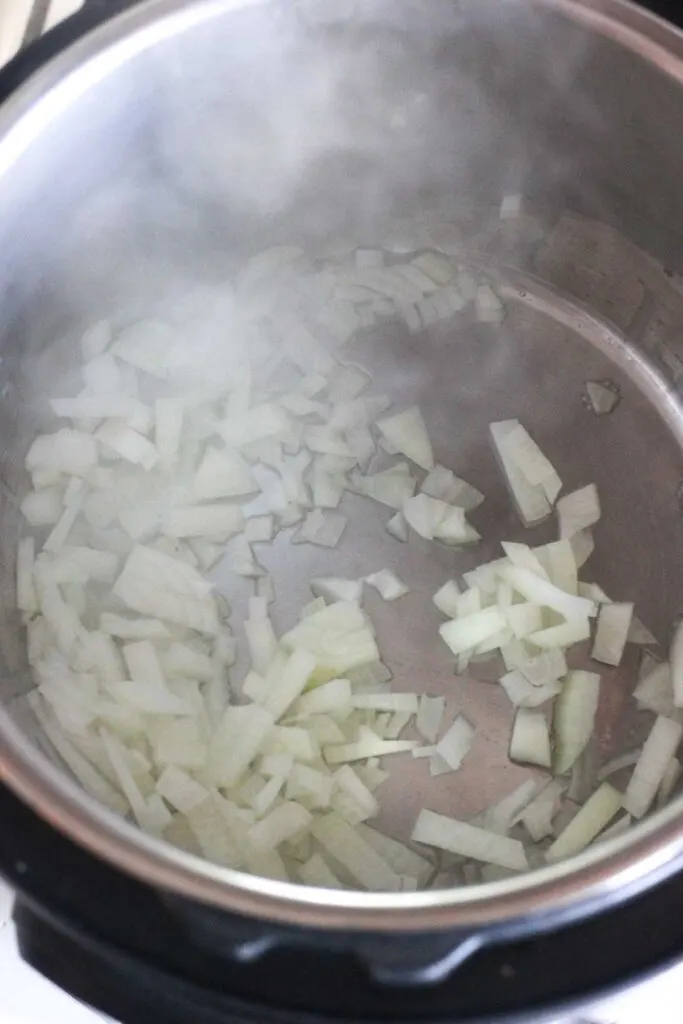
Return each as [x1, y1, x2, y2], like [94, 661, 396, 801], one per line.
[412, 810, 528, 871]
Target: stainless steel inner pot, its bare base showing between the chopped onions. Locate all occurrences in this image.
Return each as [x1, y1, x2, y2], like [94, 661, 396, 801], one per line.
[0, 0, 683, 934]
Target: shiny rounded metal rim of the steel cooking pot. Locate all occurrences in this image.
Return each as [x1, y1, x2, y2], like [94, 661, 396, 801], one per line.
[0, 0, 683, 937]
